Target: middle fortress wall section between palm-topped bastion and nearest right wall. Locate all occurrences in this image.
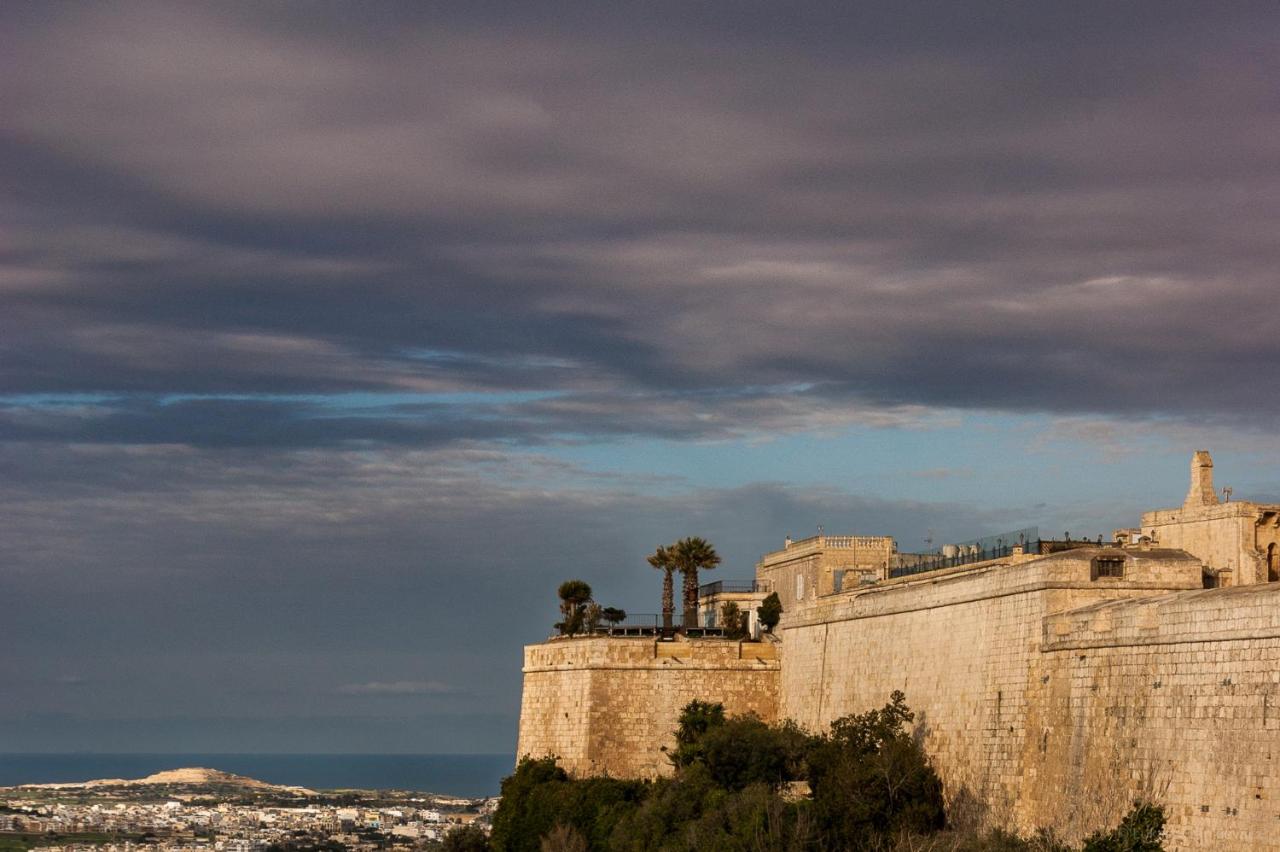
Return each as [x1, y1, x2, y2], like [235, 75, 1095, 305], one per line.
[781, 549, 1201, 830]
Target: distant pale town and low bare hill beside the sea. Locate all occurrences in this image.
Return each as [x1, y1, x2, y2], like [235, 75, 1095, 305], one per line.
[0, 769, 498, 852]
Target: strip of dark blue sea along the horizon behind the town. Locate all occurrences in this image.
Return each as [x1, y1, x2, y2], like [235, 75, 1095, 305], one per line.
[0, 753, 516, 798]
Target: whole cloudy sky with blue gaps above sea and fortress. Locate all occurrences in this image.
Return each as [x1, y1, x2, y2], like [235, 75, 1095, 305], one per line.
[0, 0, 1280, 752]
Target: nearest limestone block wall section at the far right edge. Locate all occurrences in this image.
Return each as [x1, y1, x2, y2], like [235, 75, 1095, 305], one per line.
[1023, 585, 1280, 852]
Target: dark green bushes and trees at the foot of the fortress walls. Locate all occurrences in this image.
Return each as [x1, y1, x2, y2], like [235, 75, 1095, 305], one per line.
[483, 692, 1164, 852]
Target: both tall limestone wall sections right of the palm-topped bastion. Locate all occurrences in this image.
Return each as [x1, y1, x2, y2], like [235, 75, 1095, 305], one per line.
[781, 550, 1280, 849]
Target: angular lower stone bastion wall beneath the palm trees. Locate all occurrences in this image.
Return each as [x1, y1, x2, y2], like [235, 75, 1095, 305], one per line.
[516, 629, 778, 778]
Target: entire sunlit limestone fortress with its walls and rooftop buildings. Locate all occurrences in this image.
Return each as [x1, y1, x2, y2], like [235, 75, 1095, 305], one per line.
[518, 450, 1280, 852]
